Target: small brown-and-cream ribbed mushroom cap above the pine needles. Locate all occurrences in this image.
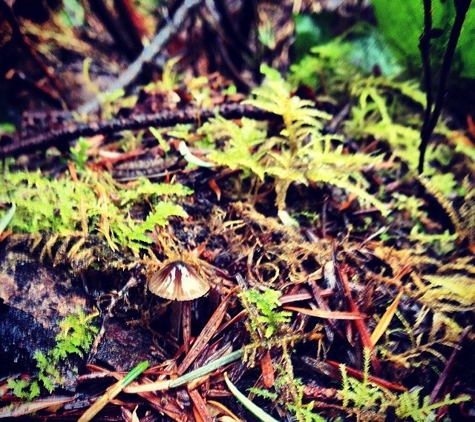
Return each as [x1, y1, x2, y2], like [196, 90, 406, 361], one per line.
[148, 261, 210, 301]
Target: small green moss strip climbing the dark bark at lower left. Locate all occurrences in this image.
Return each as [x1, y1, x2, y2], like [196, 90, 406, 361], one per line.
[8, 307, 99, 400]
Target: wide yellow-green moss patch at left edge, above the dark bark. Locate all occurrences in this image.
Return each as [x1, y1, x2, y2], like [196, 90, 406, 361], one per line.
[0, 163, 191, 252]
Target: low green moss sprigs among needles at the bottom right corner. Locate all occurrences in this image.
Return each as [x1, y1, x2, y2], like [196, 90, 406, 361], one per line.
[339, 348, 470, 422]
